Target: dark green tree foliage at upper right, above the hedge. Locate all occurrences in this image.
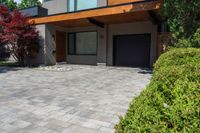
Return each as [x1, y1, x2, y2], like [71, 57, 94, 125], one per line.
[163, 0, 200, 39]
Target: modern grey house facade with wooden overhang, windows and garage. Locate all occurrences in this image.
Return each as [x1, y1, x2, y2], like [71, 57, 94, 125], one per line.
[24, 0, 163, 67]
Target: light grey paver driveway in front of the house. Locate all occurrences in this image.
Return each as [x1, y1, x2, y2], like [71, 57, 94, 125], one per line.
[0, 65, 151, 133]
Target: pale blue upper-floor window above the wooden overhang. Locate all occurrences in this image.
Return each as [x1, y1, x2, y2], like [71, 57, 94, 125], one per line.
[68, 0, 98, 12]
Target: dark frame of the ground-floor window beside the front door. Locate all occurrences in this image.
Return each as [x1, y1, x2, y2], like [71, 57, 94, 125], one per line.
[67, 31, 98, 56]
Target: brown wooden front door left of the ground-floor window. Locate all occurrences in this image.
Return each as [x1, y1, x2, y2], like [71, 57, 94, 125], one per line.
[56, 31, 67, 62]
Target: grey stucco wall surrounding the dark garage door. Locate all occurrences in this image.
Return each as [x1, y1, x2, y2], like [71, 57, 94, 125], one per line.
[107, 21, 157, 66]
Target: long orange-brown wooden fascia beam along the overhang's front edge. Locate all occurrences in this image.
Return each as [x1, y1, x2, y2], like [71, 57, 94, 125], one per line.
[30, 0, 161, 25]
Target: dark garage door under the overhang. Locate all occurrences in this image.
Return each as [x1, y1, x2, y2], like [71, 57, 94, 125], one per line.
[114, 34, 151, 67]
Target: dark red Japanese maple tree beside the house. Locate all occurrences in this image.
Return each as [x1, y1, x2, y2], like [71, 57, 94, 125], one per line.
[0, 5, 39, 65]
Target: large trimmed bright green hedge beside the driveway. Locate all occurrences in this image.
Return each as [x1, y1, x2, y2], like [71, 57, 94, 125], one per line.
[115, 48, 200, 133]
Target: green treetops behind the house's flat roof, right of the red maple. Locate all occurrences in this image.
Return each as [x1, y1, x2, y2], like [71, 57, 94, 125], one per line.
[18, 0, 41, 9]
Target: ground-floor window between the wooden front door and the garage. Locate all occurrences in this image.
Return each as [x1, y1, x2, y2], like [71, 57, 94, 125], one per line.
[68, 32, 97, 55]
